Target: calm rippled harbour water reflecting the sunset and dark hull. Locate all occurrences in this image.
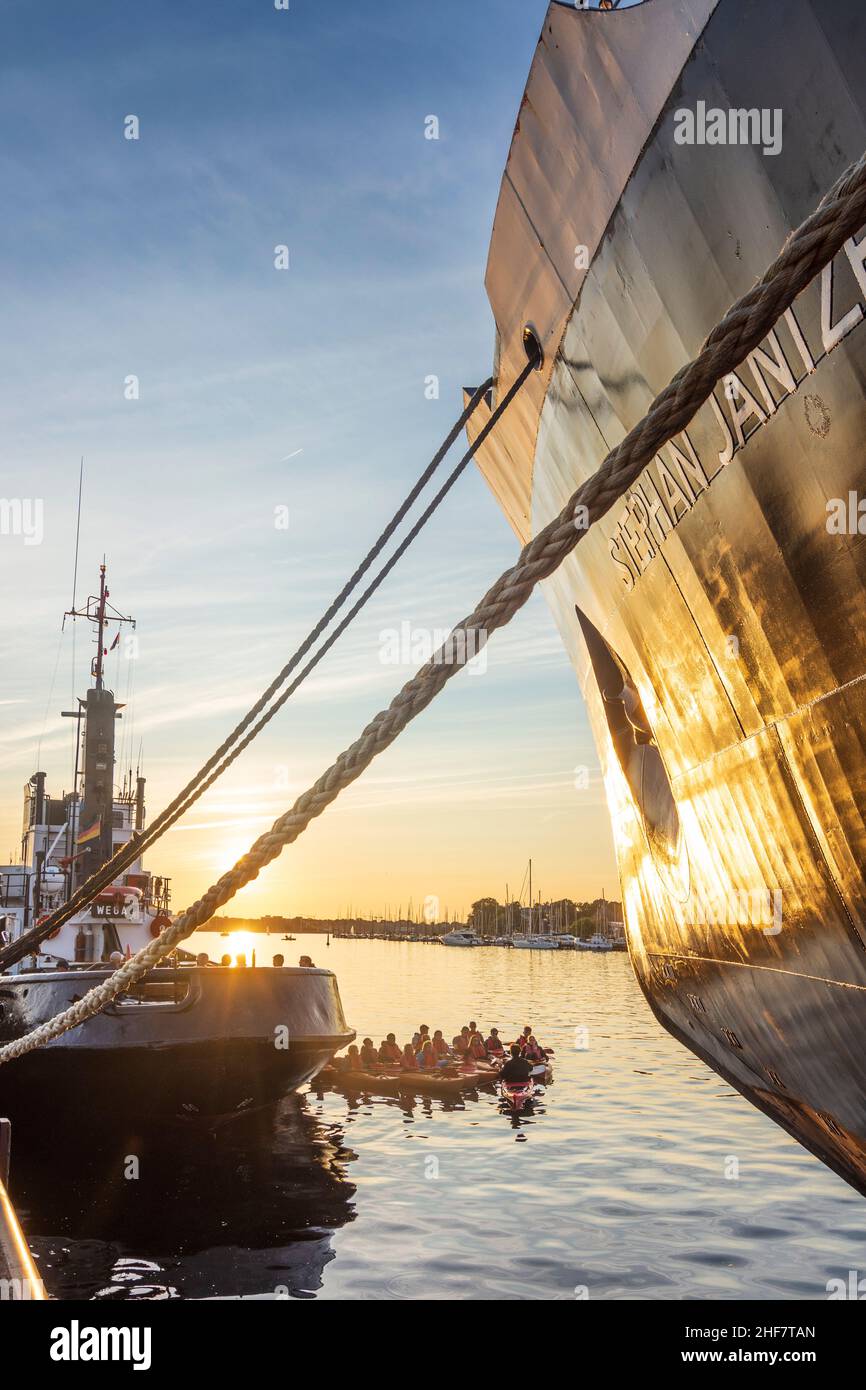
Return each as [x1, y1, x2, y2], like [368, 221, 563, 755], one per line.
[13, 933, 866, 1300]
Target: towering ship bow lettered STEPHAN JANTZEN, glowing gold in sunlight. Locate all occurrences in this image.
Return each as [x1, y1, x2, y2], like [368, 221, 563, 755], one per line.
[474, 0, 866, 1193]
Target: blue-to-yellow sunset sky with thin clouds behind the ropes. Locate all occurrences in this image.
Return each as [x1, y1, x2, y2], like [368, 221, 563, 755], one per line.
[0, 0, 619, 915]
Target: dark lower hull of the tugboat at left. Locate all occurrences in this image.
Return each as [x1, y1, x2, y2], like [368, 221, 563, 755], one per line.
[0, 967, 354, 1123]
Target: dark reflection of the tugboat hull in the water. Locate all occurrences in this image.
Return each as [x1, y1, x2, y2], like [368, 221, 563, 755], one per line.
[14, 1095, 356, 1298]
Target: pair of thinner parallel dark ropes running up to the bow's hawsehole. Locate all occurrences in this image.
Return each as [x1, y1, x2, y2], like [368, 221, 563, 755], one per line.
[0, 368, 500, 970]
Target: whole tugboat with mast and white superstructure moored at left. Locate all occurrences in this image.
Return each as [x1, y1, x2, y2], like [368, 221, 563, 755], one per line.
[0, 564, 354, 1118]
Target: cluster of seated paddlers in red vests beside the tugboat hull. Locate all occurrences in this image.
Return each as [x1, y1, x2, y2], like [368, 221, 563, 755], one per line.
[334, 1020, 548, 1072]
